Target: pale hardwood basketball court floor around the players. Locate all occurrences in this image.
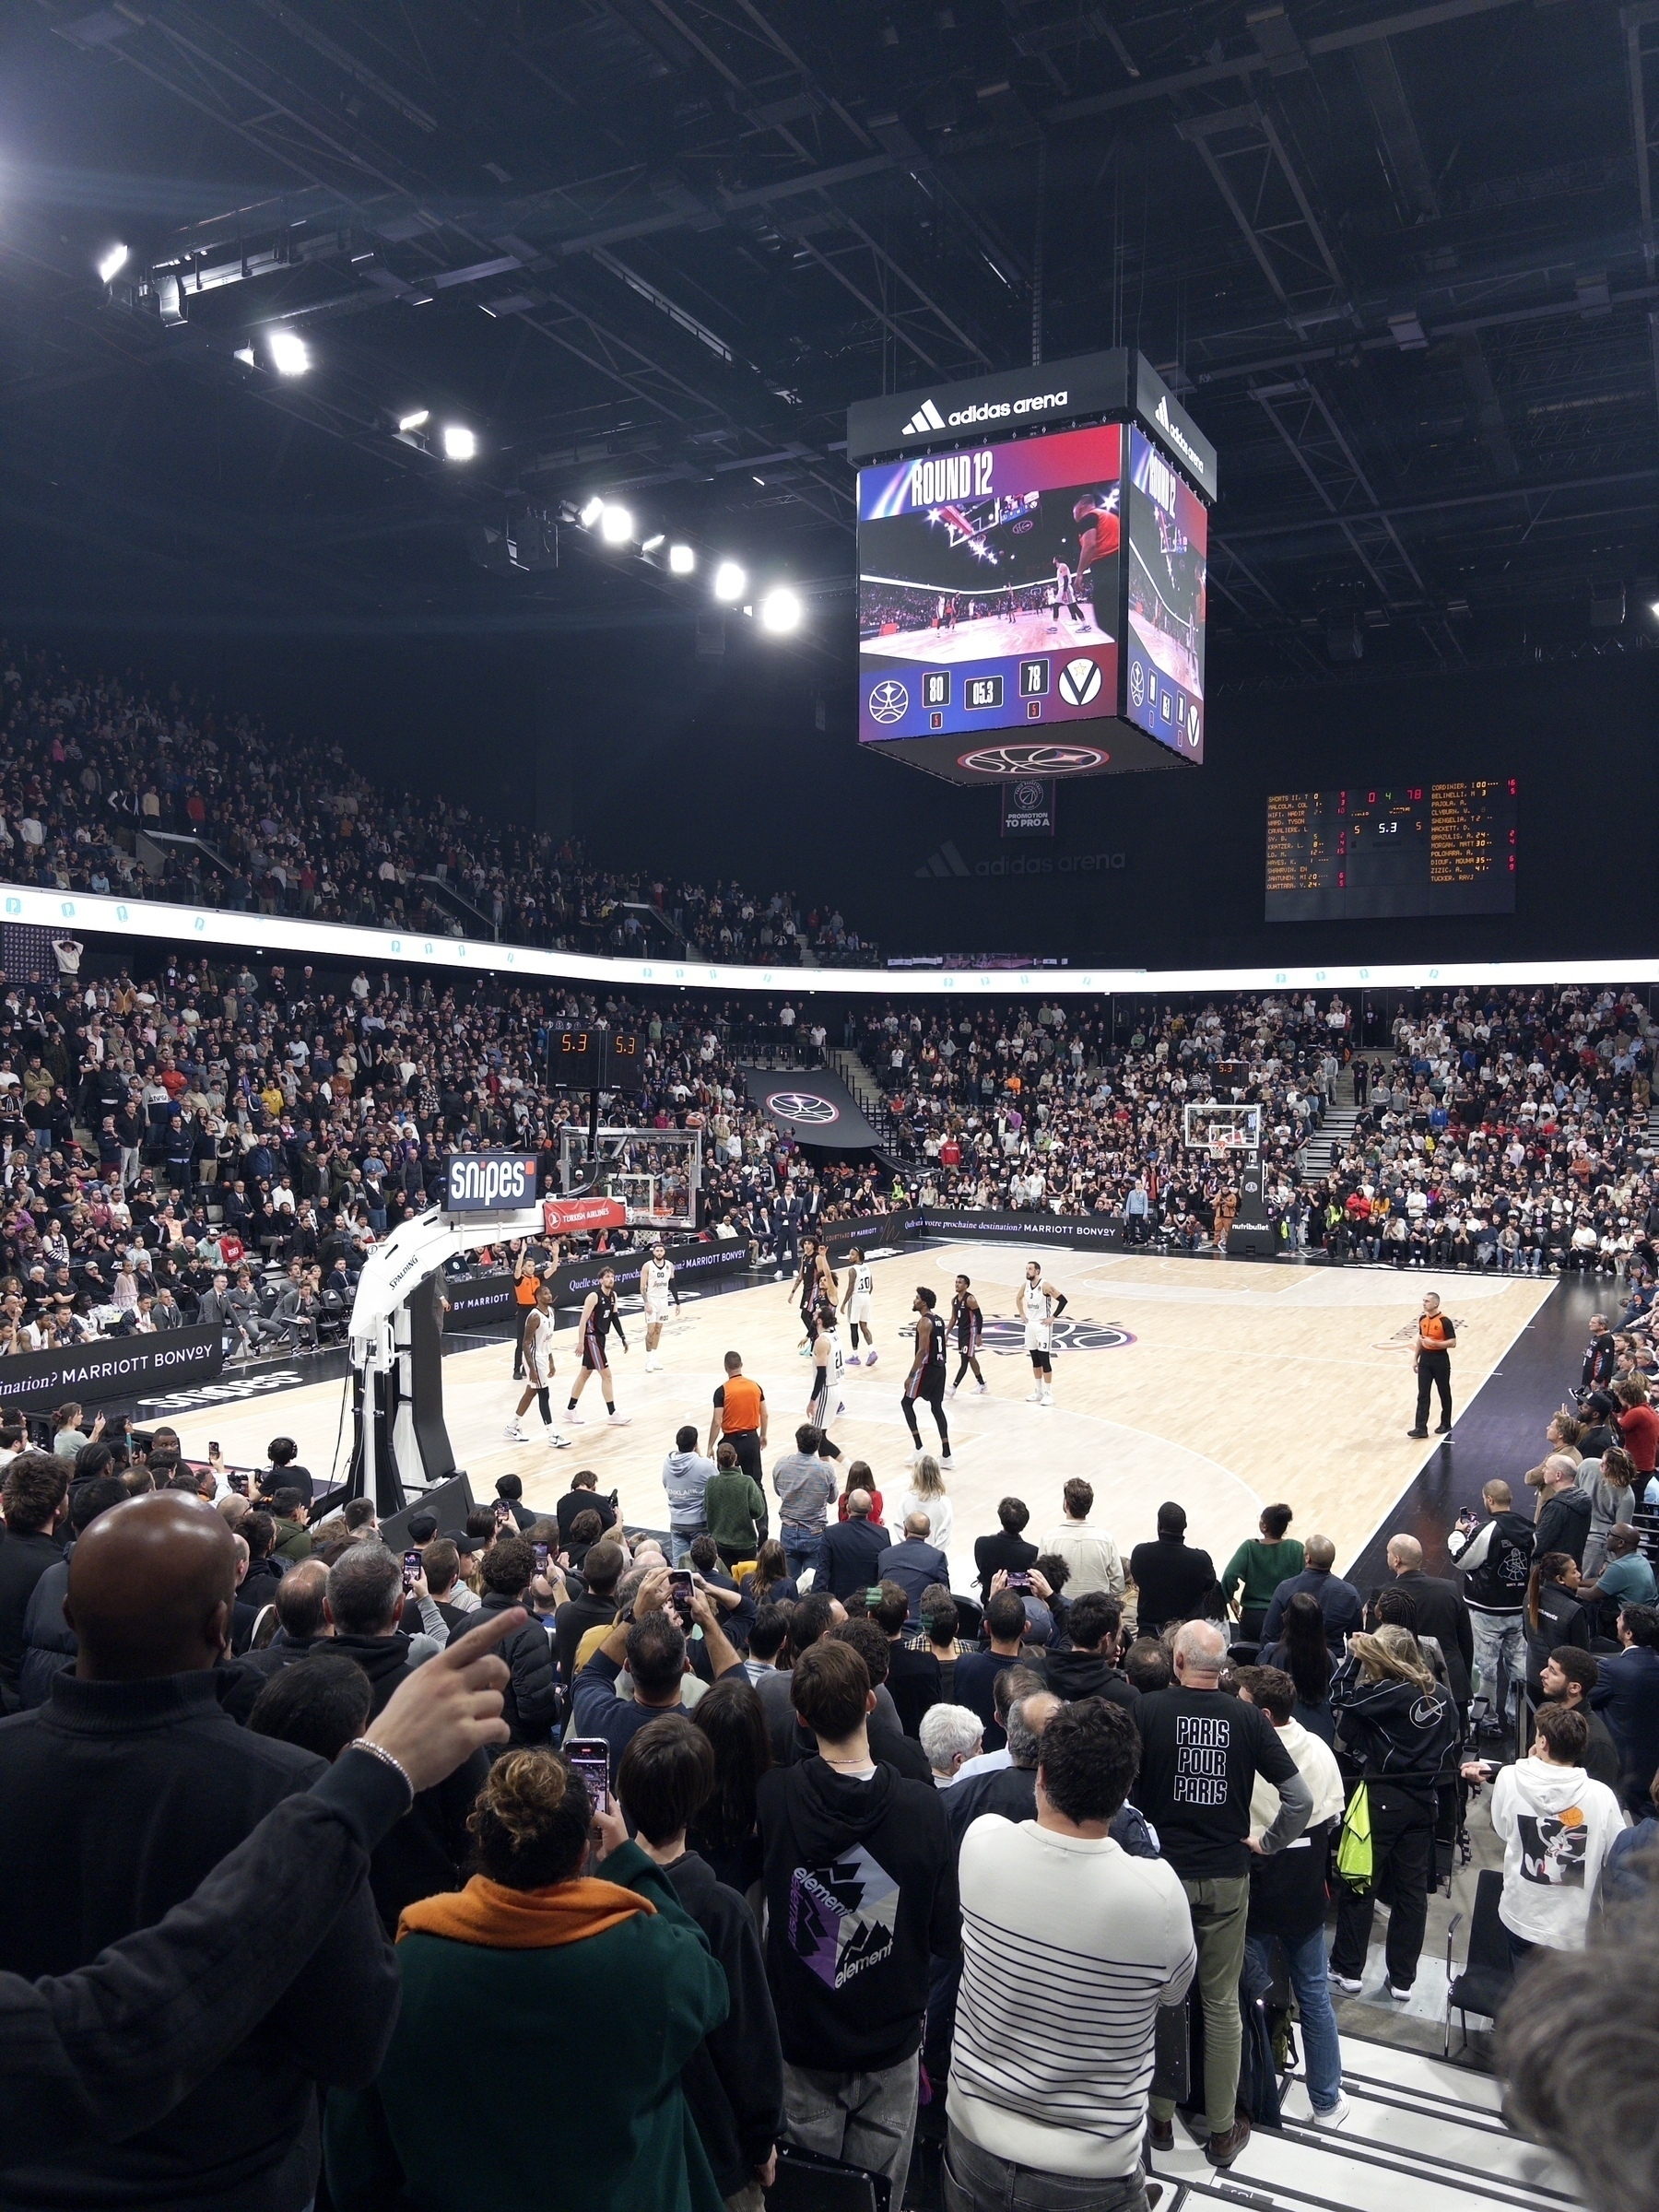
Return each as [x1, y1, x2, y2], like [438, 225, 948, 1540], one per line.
[177, 1239, 1553, 1588]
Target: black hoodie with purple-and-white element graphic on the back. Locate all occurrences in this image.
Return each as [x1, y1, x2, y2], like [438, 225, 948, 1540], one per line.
[759, 1759, 962, 2073]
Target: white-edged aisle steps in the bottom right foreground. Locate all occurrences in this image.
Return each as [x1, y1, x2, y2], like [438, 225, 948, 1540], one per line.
[1152, 2030, 1582, 2212]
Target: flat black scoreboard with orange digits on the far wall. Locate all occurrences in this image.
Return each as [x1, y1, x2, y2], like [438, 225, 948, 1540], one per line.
[1265, 776, 1515, 923]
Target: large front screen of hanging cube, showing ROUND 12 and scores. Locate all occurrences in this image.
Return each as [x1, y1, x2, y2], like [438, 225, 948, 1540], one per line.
[858, 422, 1124, 746]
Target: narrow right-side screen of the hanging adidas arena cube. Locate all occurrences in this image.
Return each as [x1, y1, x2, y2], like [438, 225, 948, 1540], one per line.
[1124, 427, 1210, 763]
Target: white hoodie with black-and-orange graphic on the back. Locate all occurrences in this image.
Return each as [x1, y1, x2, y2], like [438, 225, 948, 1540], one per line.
[1491, 1759, 1624, 1951]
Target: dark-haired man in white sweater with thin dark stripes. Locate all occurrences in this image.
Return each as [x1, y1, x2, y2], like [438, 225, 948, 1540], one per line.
[945, 1699, 1196, 2212]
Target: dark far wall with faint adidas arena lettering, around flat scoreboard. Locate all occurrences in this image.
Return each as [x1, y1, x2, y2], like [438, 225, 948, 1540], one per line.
[553, 654, 1659, 969]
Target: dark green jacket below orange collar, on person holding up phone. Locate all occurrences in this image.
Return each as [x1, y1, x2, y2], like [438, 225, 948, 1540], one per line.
[323, 1842, 730, 2212]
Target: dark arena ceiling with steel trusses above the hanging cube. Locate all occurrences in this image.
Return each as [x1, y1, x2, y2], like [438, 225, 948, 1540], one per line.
[0, 0, 1659, 688]
